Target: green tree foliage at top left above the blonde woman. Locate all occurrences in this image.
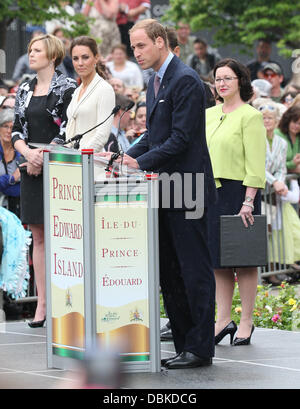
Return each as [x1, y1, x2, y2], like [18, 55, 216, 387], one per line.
[0, 0, 89, 49]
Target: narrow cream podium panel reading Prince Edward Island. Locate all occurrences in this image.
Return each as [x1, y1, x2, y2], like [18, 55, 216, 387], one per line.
[47, 153, 85, 364]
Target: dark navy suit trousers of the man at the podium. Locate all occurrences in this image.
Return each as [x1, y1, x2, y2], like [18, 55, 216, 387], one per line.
[159, 209, 215, 358]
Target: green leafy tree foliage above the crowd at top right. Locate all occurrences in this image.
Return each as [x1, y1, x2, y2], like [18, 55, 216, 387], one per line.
[164, 0, 300, 57]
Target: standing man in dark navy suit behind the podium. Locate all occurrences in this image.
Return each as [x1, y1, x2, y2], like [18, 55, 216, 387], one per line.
[100, 19, 215, 369]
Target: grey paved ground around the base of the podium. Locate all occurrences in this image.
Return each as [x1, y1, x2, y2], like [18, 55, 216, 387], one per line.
[0, 322, 300, 390]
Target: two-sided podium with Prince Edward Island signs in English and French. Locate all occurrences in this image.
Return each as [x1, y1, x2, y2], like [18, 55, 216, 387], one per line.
[43, 145, 160, 372]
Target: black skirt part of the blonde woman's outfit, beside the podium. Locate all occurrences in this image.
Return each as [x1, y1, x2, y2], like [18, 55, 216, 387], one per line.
[20, 172, 44, 224]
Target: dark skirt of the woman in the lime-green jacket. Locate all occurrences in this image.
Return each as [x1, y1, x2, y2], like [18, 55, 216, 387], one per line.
[208, 179, 261, 269]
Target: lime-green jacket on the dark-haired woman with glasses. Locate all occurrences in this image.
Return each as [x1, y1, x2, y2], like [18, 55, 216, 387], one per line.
[206, 104, 266, 188]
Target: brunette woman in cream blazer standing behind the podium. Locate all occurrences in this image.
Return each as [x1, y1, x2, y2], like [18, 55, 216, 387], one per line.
[66, 36, 115, 152]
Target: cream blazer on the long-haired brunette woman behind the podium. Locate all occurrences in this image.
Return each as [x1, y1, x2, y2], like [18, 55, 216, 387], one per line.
[66, 74, 115, 152]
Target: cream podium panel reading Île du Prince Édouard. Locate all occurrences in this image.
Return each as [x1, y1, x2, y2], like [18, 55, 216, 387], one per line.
[95, 188, 149, 362]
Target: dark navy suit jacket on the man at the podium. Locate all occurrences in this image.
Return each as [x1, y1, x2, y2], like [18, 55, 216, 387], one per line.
[126, 56, 216, 206]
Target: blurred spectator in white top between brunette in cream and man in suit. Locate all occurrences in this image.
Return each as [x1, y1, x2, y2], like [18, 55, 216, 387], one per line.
[106, 44, 144, 89]
